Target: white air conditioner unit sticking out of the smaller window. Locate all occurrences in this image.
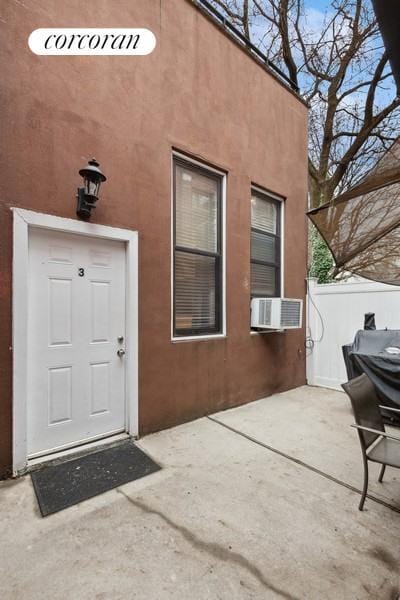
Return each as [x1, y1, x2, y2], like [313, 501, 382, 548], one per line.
[251, 298, 303, 329]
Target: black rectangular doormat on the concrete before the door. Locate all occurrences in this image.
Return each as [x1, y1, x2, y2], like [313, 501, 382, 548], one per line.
[31, 440, 161, 517]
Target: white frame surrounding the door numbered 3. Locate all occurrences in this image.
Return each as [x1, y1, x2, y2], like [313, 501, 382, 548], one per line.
[11, 208, 139, 475]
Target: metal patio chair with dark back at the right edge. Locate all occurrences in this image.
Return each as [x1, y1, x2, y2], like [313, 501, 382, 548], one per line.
[342, 373, 400, 510]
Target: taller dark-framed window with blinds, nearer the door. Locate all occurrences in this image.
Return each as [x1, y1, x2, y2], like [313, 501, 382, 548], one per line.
[174, 157, 222, 336]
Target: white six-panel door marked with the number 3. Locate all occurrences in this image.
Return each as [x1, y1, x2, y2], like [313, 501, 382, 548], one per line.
[27, 229, 125, 457]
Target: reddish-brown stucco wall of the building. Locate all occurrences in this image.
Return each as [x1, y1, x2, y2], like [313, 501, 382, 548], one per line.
[0, 0, 307, 476]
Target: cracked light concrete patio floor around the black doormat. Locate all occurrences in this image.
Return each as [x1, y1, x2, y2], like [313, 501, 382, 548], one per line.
[0, 387, 400, 600]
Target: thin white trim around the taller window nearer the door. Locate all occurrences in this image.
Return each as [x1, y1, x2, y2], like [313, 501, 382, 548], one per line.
[171, 150, 227, 343]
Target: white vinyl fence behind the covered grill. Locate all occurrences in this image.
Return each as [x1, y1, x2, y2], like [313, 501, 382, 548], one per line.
[307, 279, 400, 389]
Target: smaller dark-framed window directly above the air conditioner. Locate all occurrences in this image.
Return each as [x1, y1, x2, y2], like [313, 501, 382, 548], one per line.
[250, 190, 282, 298]
